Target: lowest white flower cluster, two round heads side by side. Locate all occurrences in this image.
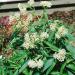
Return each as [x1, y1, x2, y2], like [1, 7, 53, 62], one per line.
[28, 59, 43, 68]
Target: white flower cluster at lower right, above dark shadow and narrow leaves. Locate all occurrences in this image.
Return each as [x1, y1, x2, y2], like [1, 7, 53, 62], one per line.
[53, 49, 66, 62]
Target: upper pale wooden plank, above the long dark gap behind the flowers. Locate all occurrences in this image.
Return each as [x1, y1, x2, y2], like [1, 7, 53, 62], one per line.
[0, 0, 75, 10]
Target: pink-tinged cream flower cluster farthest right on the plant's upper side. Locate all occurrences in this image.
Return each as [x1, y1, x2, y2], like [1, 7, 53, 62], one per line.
[55, 26, 68, 39]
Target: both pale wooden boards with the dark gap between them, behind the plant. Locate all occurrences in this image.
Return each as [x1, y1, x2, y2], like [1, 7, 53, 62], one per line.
[0, 0, 75, 16]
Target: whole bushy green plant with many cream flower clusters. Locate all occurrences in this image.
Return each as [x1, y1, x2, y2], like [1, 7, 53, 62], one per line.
[0, 0, 75, 75]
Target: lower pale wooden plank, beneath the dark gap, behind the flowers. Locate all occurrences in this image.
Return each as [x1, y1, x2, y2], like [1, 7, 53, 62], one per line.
[0, 7, 75, 16]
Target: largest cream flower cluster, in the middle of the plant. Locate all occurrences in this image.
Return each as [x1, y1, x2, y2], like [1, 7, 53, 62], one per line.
[23, 33, 39, 49]
